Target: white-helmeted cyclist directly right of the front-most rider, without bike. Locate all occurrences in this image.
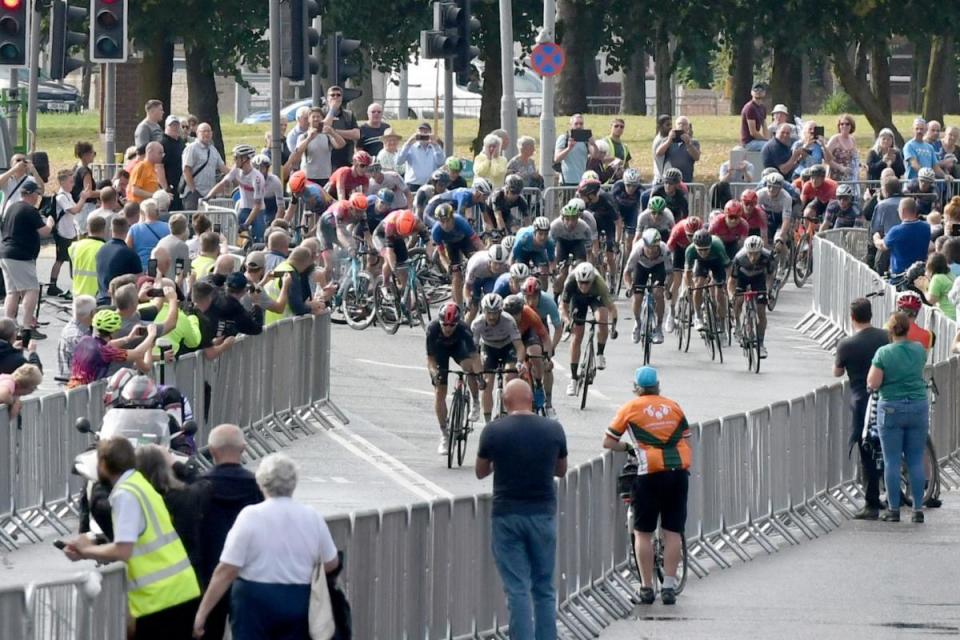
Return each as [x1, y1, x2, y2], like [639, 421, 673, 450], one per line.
[470, 293, 526, 422]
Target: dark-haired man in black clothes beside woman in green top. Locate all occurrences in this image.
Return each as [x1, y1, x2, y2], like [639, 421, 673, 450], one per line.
[833, 298, 889, 520]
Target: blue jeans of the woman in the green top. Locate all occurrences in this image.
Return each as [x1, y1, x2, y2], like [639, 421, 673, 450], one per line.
[877, 399, 930, 510]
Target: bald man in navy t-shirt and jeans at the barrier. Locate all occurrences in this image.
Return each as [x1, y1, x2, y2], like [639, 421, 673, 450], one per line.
[476, 380, 567, 639]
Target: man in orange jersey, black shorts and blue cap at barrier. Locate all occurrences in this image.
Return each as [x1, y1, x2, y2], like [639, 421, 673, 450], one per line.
[603, 367, 692, 604]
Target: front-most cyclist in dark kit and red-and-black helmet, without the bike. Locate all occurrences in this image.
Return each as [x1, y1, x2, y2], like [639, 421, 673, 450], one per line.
[427, 302, 480, 454]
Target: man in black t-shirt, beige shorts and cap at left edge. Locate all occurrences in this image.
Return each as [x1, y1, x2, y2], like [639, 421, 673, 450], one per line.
[0, 178, 54, 340]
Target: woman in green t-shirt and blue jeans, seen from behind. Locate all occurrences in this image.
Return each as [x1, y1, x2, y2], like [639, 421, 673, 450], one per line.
[867, 312, 930, 522]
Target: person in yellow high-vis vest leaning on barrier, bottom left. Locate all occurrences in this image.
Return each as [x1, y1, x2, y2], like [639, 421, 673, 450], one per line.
[64, 437, 200, 640]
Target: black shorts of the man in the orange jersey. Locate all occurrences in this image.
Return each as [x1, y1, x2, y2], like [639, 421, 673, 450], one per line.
[632, 469, 690, 533]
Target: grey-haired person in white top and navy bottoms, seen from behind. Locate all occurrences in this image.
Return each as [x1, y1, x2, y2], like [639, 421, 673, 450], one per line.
[193, 453, 340, 640]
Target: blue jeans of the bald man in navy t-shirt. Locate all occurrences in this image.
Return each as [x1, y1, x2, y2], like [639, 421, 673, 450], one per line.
[492, 514, 557, 640]
